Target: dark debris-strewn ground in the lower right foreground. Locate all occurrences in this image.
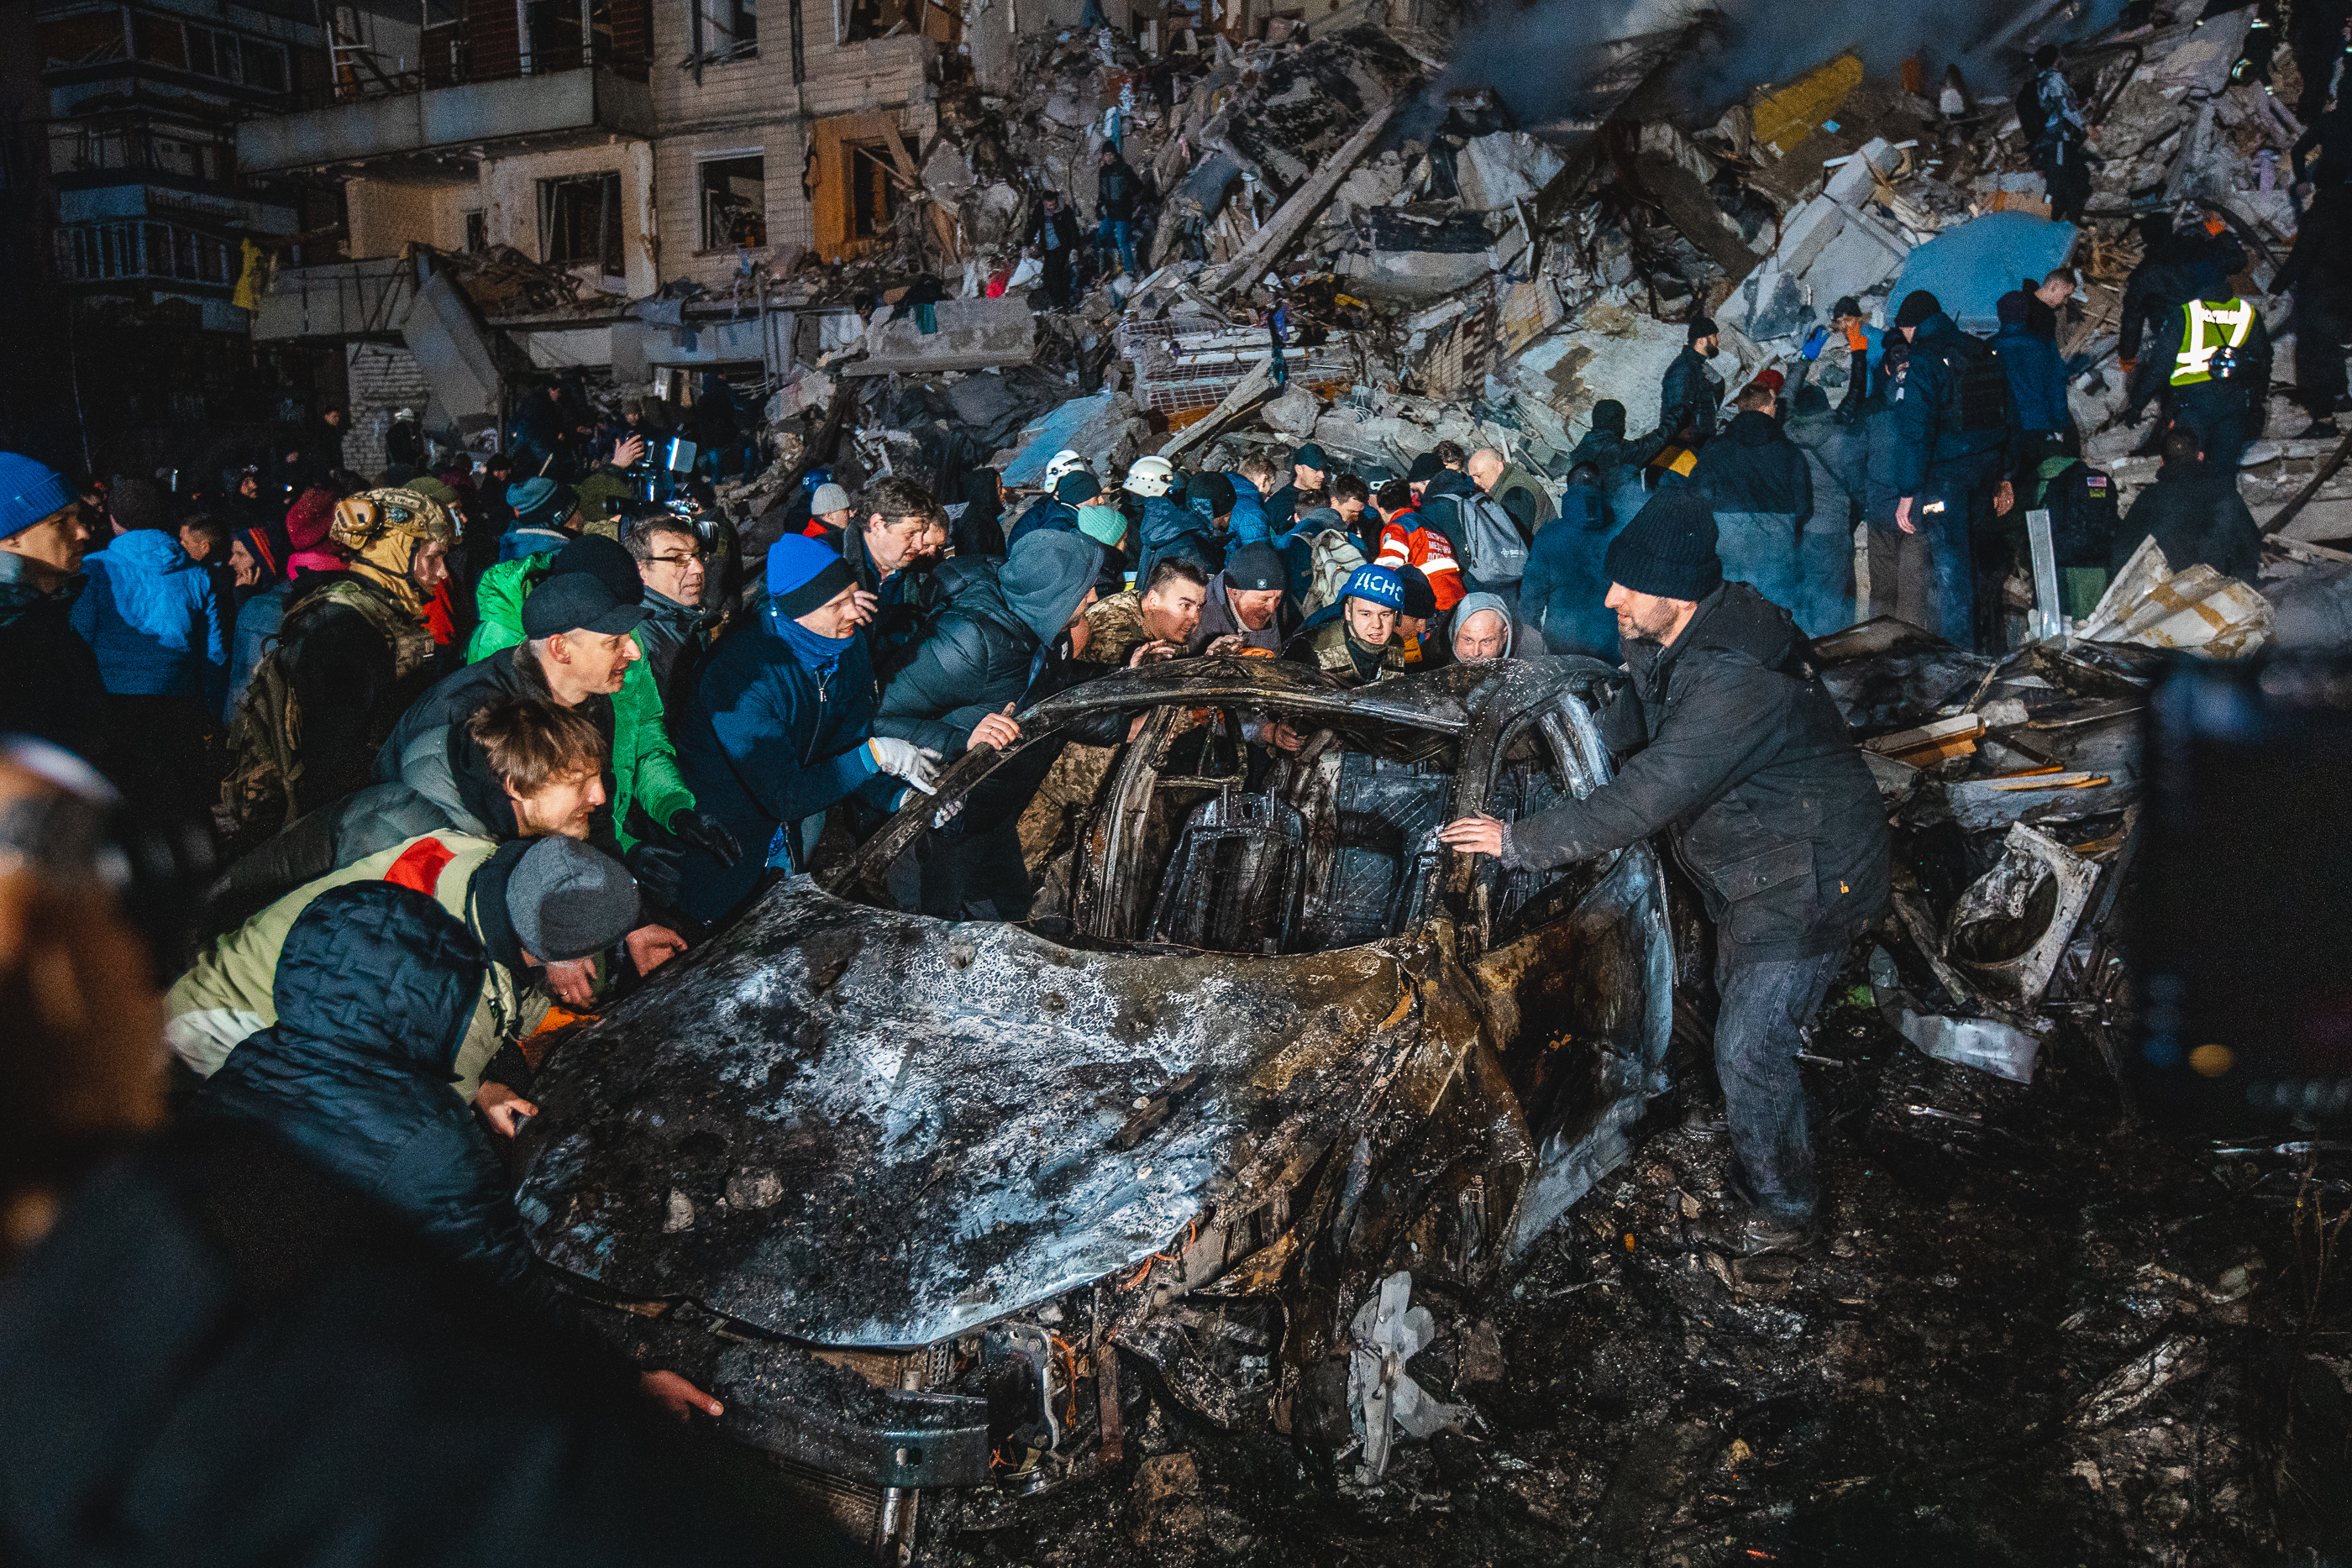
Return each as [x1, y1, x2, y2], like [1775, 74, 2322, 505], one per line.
[907, 966, 2352, 1568]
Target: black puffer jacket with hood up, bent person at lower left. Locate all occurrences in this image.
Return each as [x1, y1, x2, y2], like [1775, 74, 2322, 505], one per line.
[188, 882, 570, 1321]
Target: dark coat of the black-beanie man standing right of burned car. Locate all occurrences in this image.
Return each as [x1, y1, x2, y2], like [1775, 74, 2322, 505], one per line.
[1503, 583, 1888, 964]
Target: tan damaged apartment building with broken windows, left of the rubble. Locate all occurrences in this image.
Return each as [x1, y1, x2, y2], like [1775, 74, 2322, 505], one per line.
[238, 0, 962, 468]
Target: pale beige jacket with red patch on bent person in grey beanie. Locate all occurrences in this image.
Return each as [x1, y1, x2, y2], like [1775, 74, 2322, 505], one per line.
[162, 830, 548, 1100]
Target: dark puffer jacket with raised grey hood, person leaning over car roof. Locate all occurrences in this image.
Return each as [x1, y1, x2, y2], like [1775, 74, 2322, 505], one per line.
[875, 533, 1099, 757]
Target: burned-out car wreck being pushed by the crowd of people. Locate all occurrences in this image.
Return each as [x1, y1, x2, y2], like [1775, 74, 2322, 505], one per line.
[520, 658, 1677, 1542]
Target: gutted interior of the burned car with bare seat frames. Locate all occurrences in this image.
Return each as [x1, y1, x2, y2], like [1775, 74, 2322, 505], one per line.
[837, 658, 1606, 954]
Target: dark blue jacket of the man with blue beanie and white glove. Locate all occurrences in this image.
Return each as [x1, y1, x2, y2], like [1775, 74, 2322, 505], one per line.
[670, 600, 900, 924]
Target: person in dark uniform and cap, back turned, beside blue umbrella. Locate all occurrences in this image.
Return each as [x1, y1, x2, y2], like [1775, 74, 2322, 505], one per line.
[1887, 289, 2013, 647]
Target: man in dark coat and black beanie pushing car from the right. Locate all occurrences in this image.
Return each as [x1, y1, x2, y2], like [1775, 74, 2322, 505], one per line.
[1440, 489, 1888, 1253]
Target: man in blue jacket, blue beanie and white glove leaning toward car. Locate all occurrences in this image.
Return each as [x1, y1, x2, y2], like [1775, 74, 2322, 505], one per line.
[673, 533, 938, 926]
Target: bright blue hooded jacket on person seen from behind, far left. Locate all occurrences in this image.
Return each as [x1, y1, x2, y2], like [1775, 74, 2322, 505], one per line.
[71, 529, 228, 708]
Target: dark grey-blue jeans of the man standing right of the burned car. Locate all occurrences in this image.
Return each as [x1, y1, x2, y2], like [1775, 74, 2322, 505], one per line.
[1714, 947, 1846, 1220]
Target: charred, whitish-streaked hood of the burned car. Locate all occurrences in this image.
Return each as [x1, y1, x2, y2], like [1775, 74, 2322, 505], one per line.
[517, 877, 1420, 1347]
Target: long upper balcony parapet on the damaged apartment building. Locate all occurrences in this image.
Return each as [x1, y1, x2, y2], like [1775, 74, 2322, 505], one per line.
[238, 66, 654, 174]
